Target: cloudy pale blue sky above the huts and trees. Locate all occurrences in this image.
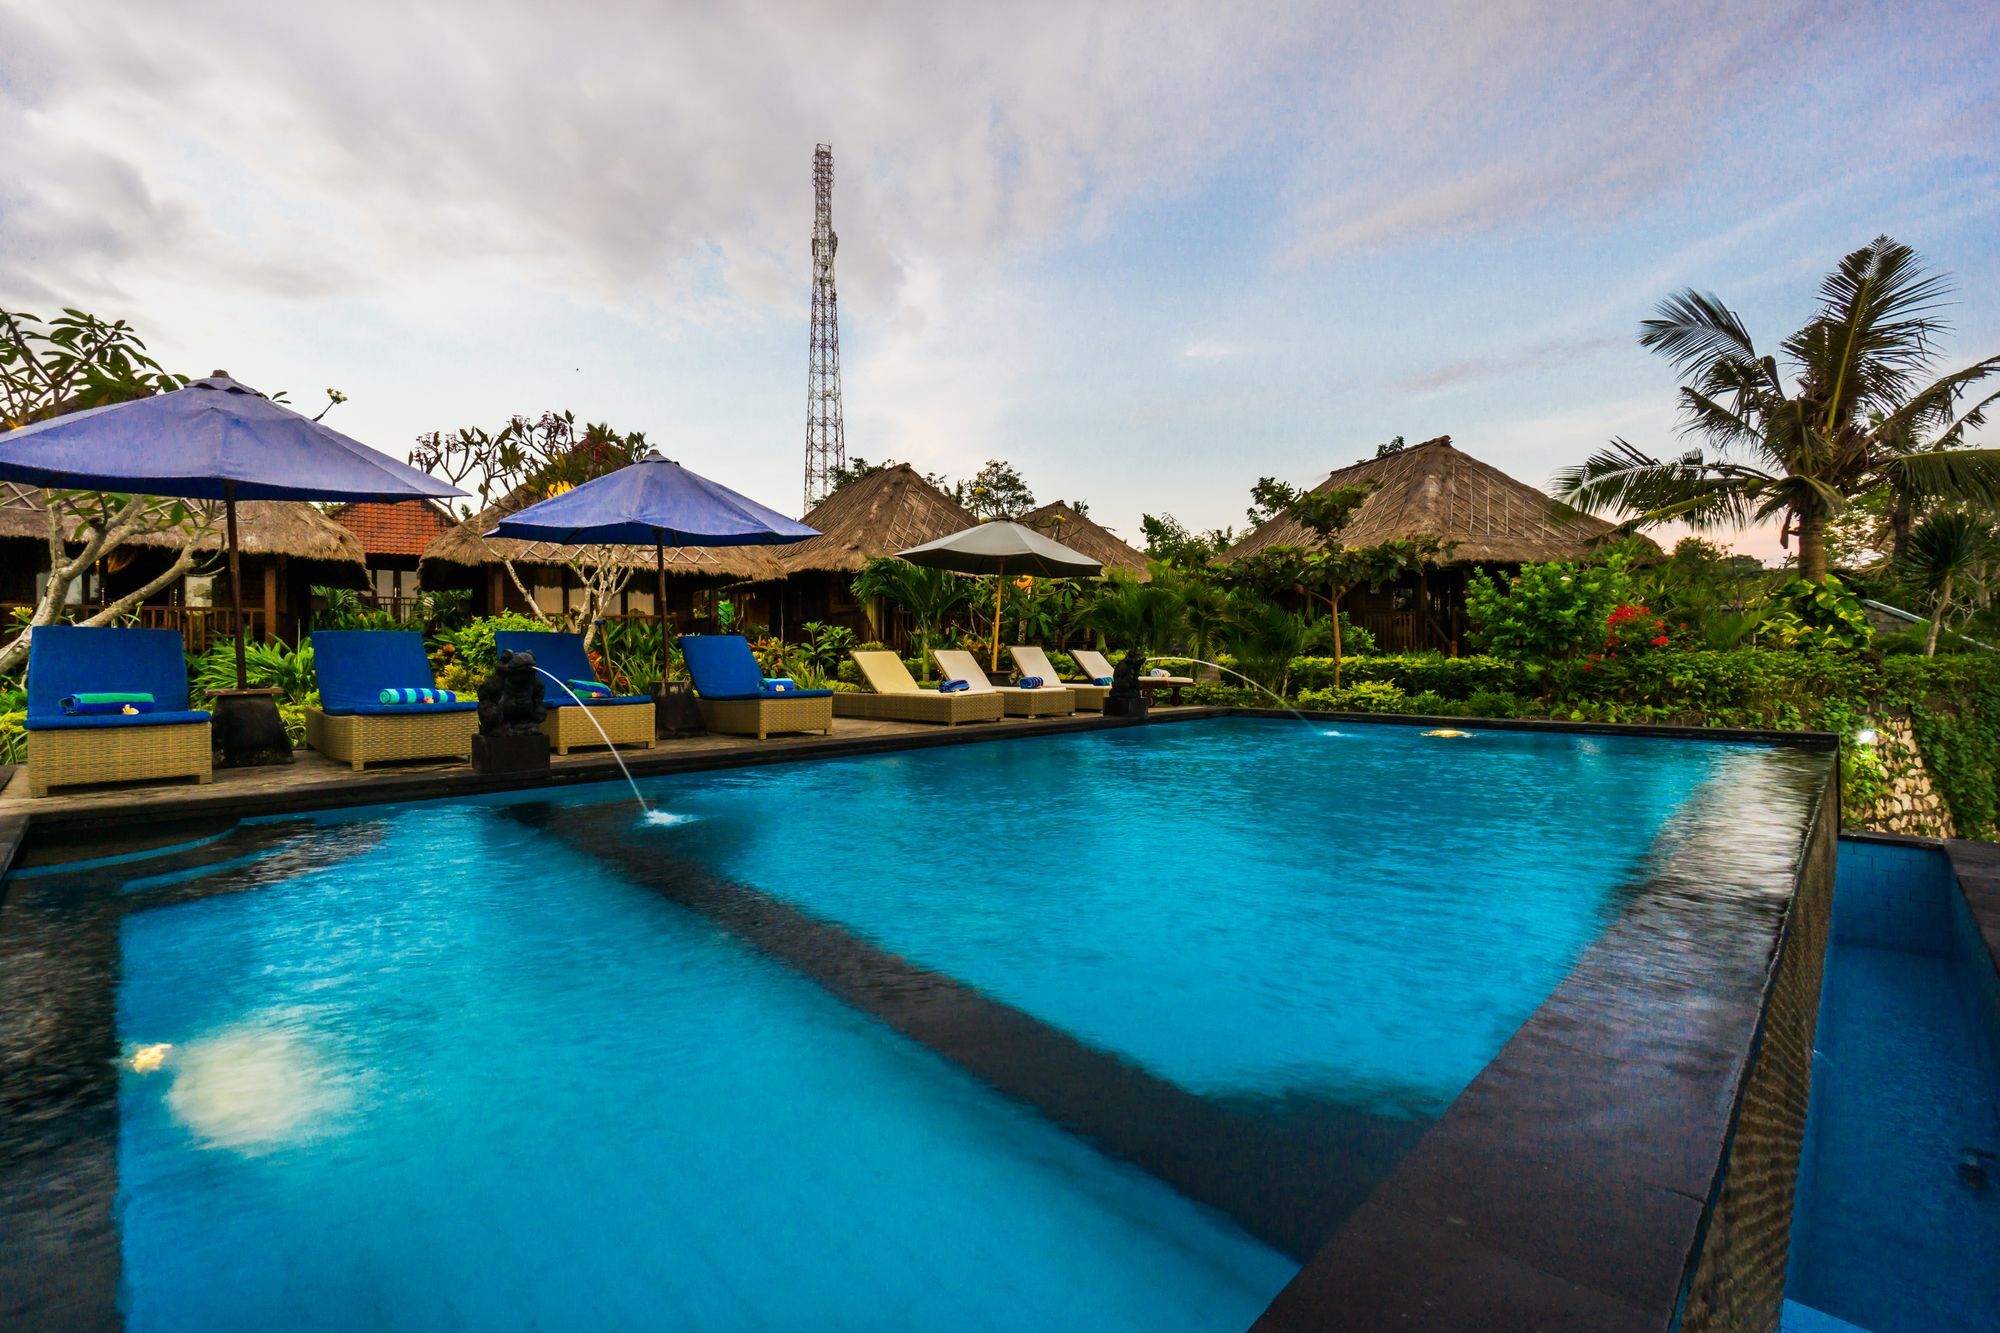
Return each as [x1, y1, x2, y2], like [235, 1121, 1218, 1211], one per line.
[0, 0, 2000, 556]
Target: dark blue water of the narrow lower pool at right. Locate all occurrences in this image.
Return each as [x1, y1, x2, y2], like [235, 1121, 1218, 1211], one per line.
[1786, 843, 2000, 1333]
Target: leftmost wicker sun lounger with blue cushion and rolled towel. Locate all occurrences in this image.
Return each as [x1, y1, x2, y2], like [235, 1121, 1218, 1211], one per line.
[26, 624, 214, 797]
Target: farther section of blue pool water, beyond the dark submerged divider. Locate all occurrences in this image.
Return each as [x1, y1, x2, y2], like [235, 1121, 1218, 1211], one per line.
[624, 719, 1772, 1115]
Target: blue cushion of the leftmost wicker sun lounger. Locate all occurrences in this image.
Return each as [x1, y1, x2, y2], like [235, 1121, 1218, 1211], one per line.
[24, 624, 208, 731]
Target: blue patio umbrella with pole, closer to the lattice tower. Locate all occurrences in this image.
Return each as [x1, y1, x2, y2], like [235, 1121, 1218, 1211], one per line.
[486, 450, 820, 679]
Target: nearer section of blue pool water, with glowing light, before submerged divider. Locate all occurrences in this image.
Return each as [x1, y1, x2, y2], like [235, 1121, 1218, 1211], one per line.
[118, 807, 1294, 1331]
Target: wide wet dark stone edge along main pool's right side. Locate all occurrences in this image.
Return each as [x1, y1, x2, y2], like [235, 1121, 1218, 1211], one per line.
[1256, 729, 1840, 1331]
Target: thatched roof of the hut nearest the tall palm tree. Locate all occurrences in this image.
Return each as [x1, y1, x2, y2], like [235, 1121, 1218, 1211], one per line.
[1222, 434, 1612, 564]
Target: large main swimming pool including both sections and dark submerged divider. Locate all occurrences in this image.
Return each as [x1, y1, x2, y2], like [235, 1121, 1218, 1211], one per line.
[8, 719, 1832, 1329]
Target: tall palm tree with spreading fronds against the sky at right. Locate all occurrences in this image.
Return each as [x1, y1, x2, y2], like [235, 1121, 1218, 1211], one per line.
[1556, 236, 2000, 582]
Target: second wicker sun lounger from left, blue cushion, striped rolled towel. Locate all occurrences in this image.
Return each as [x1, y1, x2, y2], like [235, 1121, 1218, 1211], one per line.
[306, 630, 480, 773]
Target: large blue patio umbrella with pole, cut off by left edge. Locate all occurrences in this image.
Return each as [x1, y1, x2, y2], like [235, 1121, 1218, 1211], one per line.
[0, 370, 464, 689]
